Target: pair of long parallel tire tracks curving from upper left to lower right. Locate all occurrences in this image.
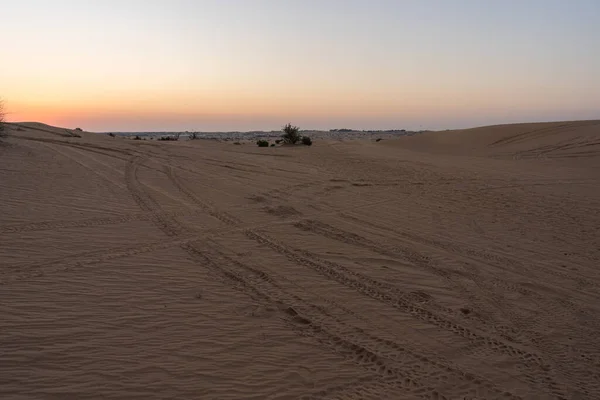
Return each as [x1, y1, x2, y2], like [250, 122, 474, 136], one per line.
[127, 158, 559, 398]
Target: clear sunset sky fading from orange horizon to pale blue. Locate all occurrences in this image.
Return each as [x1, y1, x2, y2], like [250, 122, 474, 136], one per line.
[0, 0, 600, 132]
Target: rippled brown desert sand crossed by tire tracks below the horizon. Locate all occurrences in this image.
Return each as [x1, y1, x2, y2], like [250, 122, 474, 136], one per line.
[0, 121, 600, 399]
